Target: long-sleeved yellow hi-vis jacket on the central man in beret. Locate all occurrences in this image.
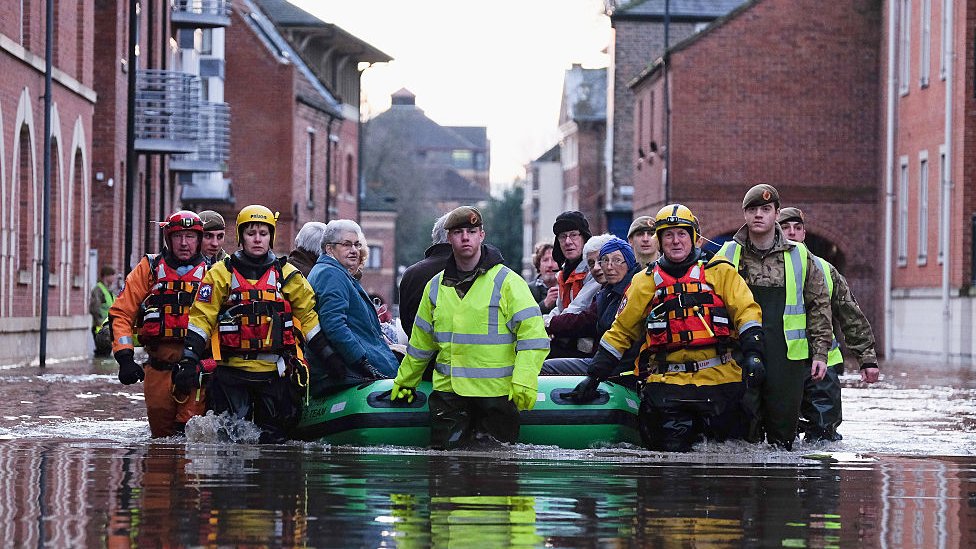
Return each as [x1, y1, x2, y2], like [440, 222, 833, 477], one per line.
[397, 264, 549, 397]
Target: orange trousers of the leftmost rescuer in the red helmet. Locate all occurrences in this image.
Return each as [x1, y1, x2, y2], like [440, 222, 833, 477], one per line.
[143, 364, 207, 438]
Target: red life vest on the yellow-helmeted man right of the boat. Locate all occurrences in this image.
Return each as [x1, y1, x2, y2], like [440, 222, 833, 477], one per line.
[644, 263, 731, 352]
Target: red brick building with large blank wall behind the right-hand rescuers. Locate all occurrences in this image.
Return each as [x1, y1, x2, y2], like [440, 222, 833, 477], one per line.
[631, 0, 883, 325]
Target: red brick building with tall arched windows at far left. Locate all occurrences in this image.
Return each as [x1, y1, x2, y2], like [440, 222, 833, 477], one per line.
[0, 0, 97, 364]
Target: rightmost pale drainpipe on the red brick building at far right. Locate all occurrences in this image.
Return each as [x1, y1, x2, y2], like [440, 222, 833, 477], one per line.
[939, 0, 955, 362]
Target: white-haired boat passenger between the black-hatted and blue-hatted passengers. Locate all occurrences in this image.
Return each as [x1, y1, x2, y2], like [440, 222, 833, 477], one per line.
[542, 234, 615, 360]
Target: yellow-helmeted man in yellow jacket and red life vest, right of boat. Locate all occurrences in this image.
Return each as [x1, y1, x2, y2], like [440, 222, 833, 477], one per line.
[574, 204, 764, 452]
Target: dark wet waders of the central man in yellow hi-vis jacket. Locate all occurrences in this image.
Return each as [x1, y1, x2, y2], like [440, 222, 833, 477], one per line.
[427, 391, 520, 450]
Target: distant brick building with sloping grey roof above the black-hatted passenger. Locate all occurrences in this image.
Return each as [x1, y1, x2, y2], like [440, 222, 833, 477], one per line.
[559, 65, 607, 234]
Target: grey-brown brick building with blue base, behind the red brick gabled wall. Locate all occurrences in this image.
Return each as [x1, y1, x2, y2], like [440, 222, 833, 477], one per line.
[606, 0, 743, 234]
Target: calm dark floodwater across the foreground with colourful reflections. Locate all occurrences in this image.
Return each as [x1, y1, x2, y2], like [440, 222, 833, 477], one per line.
[0, 440, 976, 547]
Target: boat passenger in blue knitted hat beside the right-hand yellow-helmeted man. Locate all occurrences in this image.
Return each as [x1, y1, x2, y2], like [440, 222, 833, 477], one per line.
[541, 237, 643, 386]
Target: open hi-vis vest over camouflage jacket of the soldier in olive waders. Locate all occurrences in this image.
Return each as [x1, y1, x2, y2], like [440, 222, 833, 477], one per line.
[715, 240, 812, 360]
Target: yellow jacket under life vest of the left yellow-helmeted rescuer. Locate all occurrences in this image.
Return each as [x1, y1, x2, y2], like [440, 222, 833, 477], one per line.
[188, 252, 320, 372]
